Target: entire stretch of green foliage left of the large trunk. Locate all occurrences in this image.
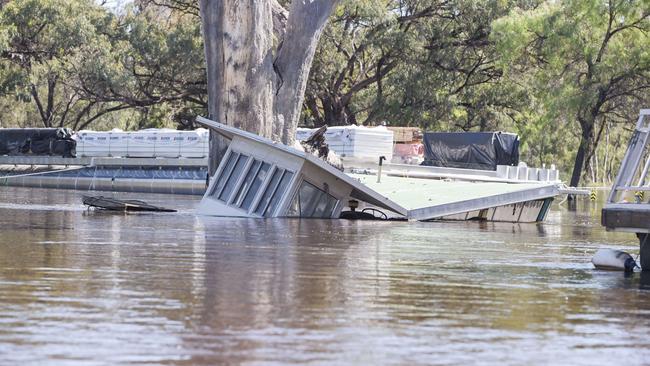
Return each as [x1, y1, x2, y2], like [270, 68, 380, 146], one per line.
[0, 0, 206, 129]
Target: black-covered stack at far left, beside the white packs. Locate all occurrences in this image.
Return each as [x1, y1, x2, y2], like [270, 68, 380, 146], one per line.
[0, 128, 77, 157]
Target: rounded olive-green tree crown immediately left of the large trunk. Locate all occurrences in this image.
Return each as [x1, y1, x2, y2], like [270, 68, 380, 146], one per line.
[67, 4, 207, 128]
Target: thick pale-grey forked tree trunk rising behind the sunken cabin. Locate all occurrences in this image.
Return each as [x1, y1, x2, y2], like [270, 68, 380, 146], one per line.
[200, 0, 338, 175]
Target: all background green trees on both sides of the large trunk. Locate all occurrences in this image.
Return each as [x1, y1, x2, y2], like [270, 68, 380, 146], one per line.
[0, 0, 650, 186]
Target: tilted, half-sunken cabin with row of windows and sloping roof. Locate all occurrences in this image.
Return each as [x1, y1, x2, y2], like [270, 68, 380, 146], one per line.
[197, 117, 408, 218]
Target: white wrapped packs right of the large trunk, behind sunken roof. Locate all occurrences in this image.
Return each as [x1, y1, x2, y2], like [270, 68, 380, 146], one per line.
[296, 126, 393, 162]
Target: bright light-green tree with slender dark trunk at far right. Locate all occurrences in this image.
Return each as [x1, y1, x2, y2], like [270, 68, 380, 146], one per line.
[494, 0, 650, 186]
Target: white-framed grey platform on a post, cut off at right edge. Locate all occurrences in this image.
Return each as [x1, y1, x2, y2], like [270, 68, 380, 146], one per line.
[602, 109, 650, 271]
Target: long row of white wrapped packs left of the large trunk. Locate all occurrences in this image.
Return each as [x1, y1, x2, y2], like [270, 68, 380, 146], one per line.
[76, 128, 209, 158]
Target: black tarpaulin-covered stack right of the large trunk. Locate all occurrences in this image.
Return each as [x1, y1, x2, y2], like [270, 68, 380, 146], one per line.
[422, 132, 519, 170]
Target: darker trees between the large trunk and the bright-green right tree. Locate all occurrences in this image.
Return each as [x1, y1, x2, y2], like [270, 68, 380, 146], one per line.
[304, 0, 537, 131]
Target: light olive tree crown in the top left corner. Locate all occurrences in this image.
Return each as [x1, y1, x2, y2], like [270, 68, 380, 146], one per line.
[0, 0, 114, 127]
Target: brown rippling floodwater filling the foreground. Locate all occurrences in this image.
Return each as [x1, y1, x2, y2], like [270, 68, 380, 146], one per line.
[0, 187, 650, 365]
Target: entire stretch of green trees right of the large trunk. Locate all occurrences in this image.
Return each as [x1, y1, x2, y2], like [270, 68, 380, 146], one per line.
[303, 0, 650, 184]
